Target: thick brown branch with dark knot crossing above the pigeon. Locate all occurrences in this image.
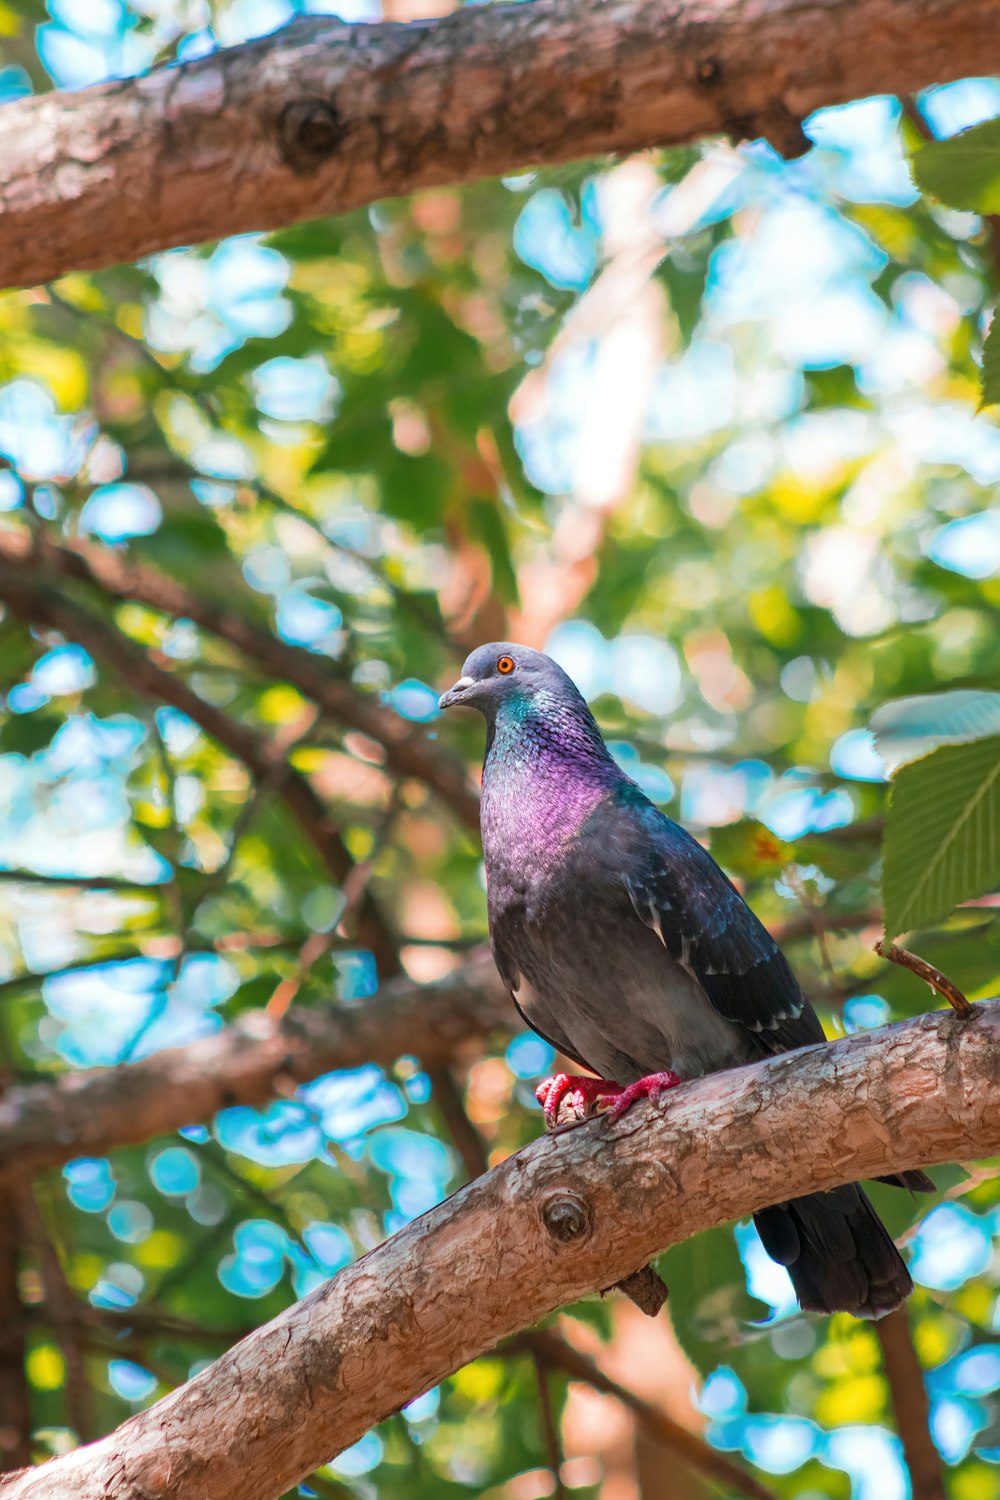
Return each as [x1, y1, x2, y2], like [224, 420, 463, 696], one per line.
[0, 0, 1000, 285]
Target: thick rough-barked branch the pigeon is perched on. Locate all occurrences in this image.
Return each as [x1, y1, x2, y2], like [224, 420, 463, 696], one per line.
[0, 1002, 1000, 1500]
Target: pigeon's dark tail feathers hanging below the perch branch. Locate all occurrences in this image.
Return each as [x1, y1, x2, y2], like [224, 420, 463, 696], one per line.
[754, 1184, 913, 1319]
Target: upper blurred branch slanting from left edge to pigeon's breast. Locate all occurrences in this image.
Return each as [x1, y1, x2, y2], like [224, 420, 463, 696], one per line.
[0, 530, 480, 830]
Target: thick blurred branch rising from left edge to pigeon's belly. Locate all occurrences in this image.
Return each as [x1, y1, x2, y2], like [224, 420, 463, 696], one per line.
[0, 956, 513, 1182]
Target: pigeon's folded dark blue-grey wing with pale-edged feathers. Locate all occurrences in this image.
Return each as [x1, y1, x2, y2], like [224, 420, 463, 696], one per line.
[613, 798, 825, 1055]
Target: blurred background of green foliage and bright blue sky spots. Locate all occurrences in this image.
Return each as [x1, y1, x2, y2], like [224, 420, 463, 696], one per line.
[0, 0, 1000, 1500]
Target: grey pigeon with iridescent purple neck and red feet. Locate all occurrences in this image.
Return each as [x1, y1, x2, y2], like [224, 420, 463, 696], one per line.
[439, 641, 934, 1319]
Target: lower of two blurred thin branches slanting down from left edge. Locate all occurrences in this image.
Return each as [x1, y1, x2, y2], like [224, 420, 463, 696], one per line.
[0, 564, 399, 975]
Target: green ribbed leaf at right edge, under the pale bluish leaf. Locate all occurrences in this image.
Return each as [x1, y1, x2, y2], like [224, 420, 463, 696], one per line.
[882, 737, 1000, 938]
